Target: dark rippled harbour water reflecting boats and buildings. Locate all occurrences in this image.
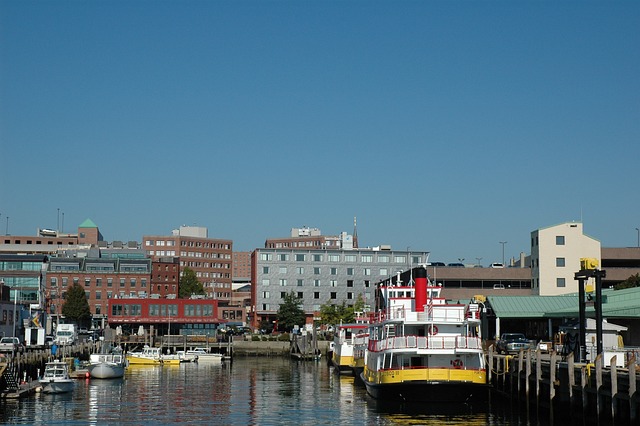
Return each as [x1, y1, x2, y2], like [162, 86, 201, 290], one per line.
[0, 357, 531, 425]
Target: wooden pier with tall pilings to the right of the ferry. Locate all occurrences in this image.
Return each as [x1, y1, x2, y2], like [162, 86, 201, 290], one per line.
[487, 347, 640, 424]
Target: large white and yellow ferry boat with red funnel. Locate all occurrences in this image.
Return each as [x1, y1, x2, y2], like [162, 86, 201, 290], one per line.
[360, 267, 489, 403]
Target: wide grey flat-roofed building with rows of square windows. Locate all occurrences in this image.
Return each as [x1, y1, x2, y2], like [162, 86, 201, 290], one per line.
[251, 248, 428, 327]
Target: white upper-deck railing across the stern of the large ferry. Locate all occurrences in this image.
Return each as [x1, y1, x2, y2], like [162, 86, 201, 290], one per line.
[368, 336, 482, 352]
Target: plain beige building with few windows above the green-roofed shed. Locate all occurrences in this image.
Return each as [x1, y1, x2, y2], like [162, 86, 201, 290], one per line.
[531, 222, 601, 296]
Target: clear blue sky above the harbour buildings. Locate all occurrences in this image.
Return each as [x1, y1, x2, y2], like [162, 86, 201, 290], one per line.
[0, 0, 640, 265]
